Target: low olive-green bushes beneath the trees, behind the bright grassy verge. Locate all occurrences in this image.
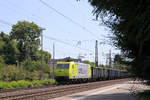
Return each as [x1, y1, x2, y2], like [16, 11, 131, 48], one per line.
[0, 62, 50, 81]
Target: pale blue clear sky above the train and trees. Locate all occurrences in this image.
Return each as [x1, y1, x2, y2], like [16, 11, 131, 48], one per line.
[0, 0, 120, 64]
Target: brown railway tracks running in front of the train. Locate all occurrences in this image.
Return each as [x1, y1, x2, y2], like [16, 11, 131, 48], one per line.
[0, 79, 129, 100]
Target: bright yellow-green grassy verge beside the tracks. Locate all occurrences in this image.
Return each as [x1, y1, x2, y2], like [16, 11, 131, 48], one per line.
[0, 79, 56, 90]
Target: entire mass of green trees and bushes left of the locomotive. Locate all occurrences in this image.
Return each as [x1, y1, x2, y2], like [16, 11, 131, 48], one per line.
[0, 21, 51, 82]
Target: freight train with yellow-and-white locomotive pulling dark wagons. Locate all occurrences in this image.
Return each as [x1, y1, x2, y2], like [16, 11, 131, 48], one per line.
[54, 61, 128, 82]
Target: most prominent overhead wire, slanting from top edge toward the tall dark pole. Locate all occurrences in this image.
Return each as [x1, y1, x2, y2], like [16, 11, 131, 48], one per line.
[39, 0, 99, 40]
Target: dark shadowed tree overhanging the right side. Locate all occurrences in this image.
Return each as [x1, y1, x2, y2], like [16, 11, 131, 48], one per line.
[89, 0, 150, 80]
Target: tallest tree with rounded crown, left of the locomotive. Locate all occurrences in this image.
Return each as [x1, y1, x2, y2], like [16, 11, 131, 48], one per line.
[10, 21, 42, 61]
